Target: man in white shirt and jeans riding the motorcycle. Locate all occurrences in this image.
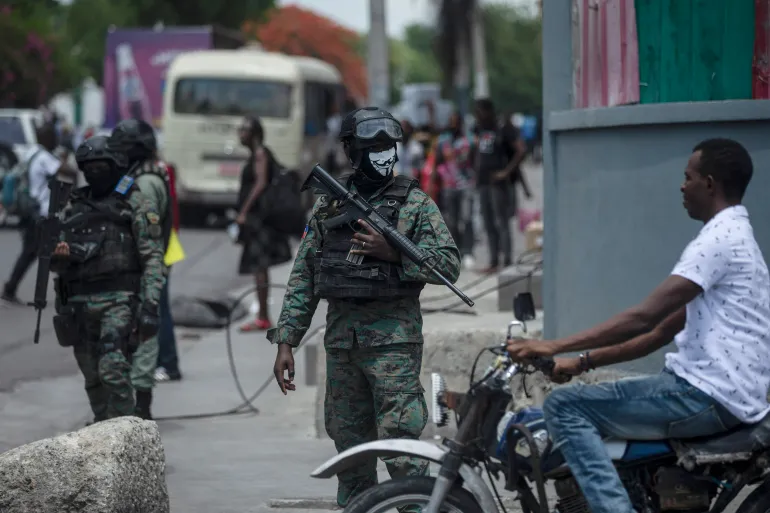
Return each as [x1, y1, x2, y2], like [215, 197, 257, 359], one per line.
[508, 139, 770, 513]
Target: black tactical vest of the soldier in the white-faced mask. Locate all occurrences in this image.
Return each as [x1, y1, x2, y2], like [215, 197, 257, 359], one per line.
[313, 175, 425, 302]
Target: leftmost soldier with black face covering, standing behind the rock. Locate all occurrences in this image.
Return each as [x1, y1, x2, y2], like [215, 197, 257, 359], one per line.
[51, 137, 166, 422]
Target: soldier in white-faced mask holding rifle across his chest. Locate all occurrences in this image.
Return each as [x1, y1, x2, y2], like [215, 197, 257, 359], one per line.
[268, 107, 460, 506]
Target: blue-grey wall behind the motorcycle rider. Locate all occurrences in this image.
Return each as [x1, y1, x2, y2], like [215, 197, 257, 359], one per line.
[543, 0, 770, 372]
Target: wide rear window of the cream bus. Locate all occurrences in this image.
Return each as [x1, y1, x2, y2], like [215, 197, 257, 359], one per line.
[174, 77, 292, 119]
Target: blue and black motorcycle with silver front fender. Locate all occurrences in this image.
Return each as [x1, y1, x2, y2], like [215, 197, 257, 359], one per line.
[311, 293, 770, 513]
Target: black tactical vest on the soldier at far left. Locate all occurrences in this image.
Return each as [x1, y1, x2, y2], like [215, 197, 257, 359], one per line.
[59, 185, 142, 297]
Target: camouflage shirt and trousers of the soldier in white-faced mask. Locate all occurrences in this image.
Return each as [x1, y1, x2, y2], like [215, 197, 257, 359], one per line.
[268, 179, 460, 505]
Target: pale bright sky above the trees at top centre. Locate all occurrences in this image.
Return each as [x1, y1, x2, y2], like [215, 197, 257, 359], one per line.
[278, 0, 535, 38]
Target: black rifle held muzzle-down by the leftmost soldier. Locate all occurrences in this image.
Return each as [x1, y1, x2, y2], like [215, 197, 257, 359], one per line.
[29, 176, 73, 344]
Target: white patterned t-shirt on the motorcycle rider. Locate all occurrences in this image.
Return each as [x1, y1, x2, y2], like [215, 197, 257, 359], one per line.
[666, 205, 770, 423]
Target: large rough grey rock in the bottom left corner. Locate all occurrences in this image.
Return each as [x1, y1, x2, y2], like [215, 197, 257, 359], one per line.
[0, 417, 169, 513]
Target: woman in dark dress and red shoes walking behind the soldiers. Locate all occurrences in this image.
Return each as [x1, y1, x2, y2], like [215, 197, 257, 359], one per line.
[235, 116, 291, 332]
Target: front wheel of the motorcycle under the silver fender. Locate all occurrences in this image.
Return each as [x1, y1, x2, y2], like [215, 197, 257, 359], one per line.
[344, 476, 482, 513]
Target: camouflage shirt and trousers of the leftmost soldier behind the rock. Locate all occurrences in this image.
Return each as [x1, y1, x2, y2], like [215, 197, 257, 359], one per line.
[52, 186, 166, 421]
